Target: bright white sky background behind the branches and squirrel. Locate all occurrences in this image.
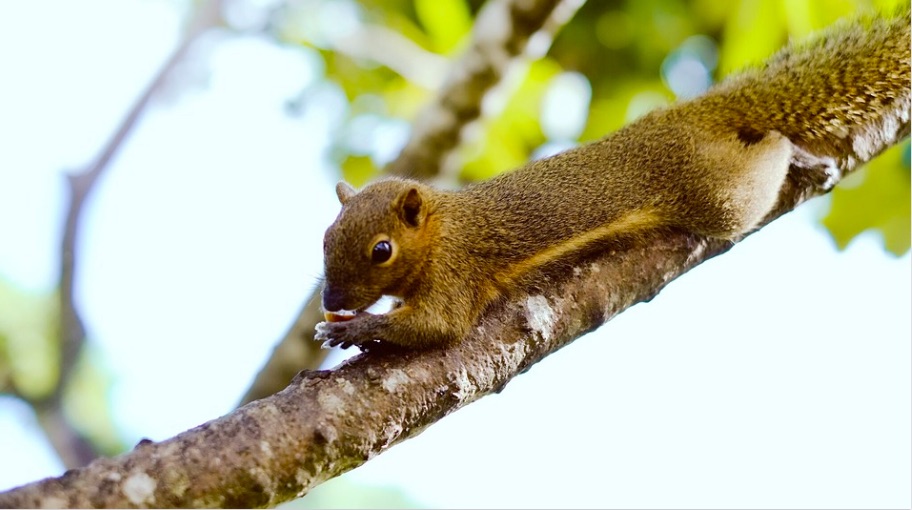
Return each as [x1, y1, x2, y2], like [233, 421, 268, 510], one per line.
[0, 0, 912, 508]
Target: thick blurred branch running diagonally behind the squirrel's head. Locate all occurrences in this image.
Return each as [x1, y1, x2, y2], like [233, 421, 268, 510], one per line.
[240, 0, 583, 405]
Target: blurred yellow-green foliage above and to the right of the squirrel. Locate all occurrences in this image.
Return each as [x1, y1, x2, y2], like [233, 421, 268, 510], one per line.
[279, 0, 909, 254]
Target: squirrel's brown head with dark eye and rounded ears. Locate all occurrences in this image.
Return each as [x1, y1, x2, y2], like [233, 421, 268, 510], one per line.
[323, 179, 432, 317]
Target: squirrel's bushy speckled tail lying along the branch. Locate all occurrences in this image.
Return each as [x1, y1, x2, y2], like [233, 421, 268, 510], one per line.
[705, 5, 912, 161]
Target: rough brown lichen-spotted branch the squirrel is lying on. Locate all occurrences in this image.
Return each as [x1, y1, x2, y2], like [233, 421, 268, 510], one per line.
[0, 7, 912, 507]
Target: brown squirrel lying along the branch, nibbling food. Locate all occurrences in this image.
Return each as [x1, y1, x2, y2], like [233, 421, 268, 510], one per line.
[316, 8, 910, 348]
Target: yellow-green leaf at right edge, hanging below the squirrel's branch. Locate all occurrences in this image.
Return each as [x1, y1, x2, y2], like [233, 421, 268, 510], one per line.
[823, 141, 910, 256]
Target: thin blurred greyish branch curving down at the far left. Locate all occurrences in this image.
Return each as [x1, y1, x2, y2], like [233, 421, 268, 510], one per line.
[3, 0, 222, 468]
